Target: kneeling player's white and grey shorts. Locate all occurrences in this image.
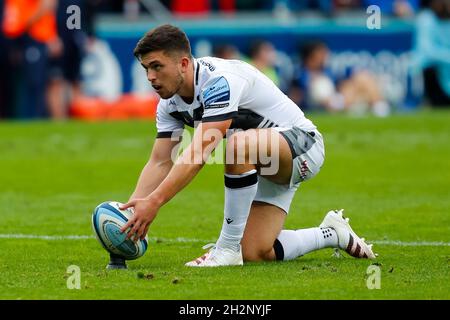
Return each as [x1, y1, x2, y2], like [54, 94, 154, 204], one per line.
[254, 128, 325, 214]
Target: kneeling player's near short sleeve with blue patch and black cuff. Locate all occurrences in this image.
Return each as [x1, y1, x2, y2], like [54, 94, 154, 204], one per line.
[201, 75, 247, 122]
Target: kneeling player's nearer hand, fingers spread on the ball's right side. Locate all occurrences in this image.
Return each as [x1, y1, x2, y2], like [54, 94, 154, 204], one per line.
[119, 199, 159, 242]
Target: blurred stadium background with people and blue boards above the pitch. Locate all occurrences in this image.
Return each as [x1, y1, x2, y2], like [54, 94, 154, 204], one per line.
[0, 0, 450, 119]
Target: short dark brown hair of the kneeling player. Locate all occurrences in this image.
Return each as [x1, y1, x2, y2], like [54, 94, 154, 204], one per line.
[133, 24, 192, 59]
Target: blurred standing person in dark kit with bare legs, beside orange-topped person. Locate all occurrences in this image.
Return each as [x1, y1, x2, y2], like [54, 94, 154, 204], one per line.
[47, 0, 87, 119]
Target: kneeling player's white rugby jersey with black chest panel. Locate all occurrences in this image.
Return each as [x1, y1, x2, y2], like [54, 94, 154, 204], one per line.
[156, 57, 316, 138]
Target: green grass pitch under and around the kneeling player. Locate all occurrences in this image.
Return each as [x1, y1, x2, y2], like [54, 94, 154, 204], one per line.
[0, 111, 450, 300]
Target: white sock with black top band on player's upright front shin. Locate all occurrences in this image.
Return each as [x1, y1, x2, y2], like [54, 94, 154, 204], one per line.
[216, 170, 258, 251]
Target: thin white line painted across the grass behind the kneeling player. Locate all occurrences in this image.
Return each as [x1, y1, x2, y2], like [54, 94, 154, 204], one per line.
[0, 233, 450, 247]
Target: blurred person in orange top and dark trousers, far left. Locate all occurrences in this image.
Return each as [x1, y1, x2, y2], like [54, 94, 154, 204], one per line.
[2, 0, 61, 118]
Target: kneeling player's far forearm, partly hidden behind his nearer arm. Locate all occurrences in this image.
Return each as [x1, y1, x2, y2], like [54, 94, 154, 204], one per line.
[130, 160, 173, 200]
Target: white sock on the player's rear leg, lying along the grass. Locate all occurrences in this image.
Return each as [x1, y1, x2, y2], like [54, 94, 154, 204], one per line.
[274, 228, 338, 260]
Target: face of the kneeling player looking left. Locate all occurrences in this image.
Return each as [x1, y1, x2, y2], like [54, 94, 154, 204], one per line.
[141, 51, 184, 99]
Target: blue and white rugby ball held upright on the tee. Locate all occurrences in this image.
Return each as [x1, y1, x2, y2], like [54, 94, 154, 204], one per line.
[92, 201, 148, 260]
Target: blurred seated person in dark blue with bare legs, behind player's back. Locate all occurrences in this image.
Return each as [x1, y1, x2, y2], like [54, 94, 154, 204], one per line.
[290, 41, 390, 116]
